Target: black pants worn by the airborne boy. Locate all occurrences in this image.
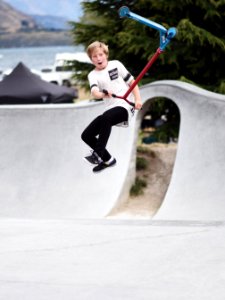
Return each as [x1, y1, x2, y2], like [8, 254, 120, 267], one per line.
[81, 106, 128, 161]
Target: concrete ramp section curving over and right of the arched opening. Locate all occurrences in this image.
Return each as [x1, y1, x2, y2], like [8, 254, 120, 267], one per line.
[142, 81, 225, 220]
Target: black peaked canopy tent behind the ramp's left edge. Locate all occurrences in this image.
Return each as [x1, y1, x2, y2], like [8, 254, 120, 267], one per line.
[0, 62, 77, 104]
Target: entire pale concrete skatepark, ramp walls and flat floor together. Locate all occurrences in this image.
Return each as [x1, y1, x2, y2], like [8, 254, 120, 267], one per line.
[0, 81, 225, 300]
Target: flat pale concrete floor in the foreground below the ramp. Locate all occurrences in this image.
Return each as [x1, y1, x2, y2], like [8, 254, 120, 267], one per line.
[0, 219, 225, 300]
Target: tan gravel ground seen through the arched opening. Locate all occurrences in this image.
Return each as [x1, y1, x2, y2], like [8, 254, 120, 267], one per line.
[110, 143, 177, 218]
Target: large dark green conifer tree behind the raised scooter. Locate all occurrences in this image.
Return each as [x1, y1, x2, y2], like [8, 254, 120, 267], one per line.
[71, 0, 225, 94]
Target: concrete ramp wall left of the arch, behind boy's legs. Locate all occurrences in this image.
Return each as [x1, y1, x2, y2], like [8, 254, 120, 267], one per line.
[0, 102, 135, 218]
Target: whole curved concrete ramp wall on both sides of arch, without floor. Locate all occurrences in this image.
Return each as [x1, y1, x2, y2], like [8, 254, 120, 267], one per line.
[0, 81, 225, 220]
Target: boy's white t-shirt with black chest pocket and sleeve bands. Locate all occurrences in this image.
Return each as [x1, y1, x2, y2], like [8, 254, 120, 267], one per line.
[88, 60, 134, 126]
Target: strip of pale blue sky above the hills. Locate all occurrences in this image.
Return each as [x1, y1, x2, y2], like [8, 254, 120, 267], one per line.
[4, 0, 82, 21]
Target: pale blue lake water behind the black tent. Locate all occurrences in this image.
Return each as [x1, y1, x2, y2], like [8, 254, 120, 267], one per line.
[0, 46, 84, 71]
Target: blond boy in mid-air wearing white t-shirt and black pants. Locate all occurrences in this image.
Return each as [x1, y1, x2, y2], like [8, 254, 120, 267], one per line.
[81, 41, 142, 173]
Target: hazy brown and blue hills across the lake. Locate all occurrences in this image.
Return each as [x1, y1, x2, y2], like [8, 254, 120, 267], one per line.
[0, 0, 72, 48]
